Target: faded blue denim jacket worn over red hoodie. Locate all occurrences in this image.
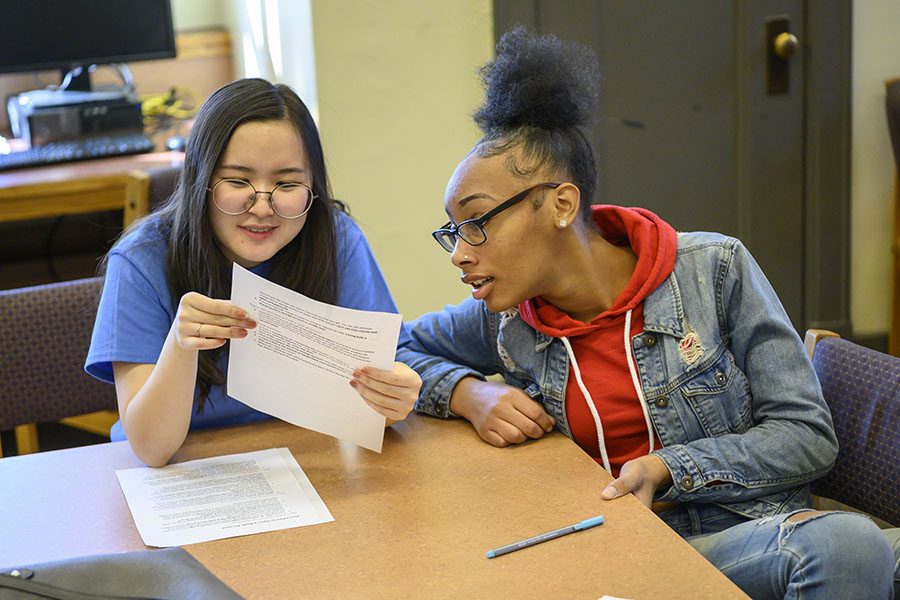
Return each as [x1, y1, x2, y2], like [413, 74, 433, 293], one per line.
[398, 232, 837, 535]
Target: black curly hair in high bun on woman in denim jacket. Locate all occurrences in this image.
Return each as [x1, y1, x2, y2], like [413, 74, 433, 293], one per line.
[473, 25, 600, 227]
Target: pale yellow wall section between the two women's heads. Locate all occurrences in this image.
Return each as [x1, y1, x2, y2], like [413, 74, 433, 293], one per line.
[312, 0, 493, 319]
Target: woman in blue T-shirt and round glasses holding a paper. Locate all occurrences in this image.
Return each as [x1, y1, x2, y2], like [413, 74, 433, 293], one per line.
[85, 79, 420, 466]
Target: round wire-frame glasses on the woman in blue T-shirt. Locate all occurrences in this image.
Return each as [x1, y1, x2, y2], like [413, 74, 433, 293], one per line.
[206, 179, 317, 220]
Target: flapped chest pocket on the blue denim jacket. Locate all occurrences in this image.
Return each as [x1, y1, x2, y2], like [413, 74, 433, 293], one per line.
[680, 347, 752, 437]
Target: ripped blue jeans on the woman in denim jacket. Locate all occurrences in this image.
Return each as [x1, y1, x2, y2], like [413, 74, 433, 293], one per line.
[687, 510, 900, 600]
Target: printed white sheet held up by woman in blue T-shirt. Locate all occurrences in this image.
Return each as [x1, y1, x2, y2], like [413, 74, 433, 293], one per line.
[228, 263, 403, 452]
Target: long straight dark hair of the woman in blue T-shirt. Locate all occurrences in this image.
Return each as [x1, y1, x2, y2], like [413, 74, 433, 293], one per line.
[148, 79, 346, 408]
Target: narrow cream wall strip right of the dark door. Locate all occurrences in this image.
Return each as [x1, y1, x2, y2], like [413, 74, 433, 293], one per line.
[850, 0, 900, 335]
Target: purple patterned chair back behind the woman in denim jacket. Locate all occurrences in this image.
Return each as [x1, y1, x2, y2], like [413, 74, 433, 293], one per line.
[813, 337, 900, 525]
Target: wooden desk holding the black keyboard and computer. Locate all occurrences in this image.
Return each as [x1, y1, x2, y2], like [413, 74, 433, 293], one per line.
[0, 152, 184, 224]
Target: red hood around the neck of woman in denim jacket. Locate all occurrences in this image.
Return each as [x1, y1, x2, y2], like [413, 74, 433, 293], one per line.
[519, 204, 678, 337]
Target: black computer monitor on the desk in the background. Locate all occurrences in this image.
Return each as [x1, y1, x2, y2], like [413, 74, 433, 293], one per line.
[0, 0, 175, 91]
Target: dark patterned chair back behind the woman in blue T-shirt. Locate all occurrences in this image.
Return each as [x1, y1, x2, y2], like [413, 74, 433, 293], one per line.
[0, 277, 116, 431]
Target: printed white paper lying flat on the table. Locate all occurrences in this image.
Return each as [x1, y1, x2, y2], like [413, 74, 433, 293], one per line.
[116, 448, 334, 547]
